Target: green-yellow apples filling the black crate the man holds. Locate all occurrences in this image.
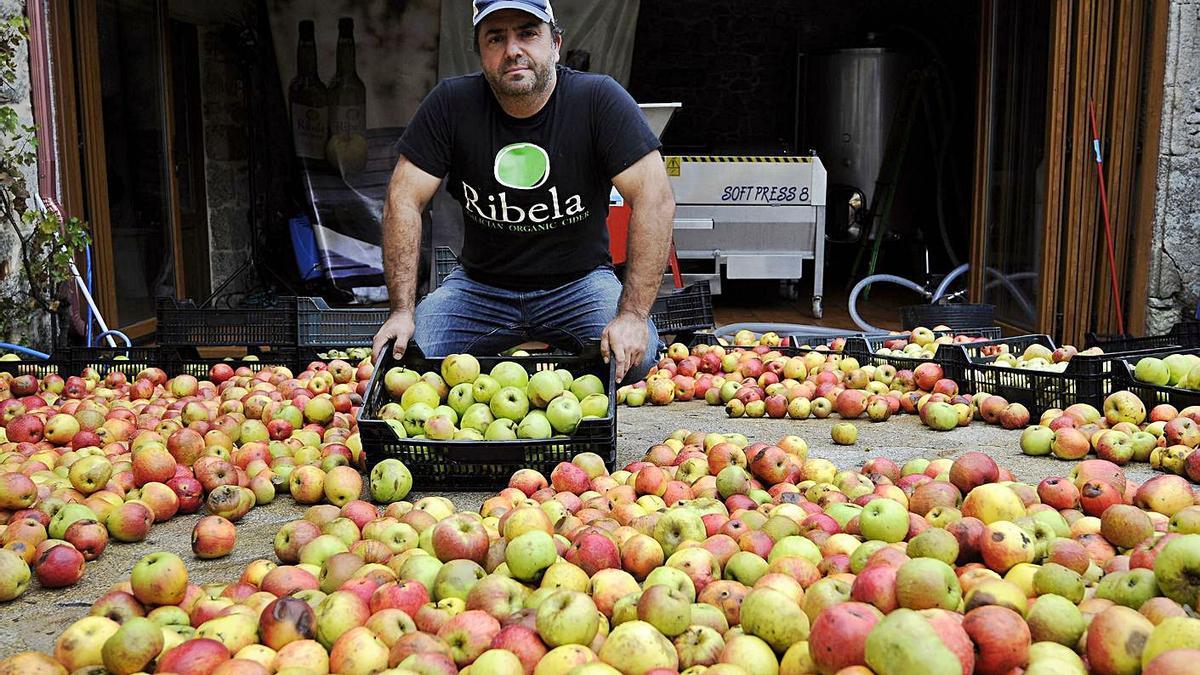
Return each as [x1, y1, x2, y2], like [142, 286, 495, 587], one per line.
[379, 354, 608, 441]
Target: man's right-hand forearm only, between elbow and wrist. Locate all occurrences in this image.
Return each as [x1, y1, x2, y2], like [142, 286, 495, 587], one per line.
[618, 192, 674, 318]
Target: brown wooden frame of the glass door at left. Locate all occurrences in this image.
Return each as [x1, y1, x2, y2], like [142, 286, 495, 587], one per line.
[49, 0, 186, 338]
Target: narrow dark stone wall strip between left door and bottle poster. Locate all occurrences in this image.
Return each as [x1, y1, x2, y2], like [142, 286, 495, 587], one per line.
[198, 24, 254, 298]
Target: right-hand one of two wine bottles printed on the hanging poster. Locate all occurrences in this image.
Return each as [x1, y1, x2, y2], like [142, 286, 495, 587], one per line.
[325, 17, 367, 175]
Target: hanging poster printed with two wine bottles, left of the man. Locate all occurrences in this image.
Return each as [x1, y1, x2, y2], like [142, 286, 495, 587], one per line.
[268, 0, 442, 301]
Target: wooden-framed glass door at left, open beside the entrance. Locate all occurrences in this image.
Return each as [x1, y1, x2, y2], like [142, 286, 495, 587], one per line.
[50, 0, 186, 338]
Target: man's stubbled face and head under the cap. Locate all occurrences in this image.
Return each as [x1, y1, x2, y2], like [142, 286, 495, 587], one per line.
[479, 10, 562, 96]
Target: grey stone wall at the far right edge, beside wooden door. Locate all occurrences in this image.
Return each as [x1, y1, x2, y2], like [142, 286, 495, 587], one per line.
[1146, 0, 1200, 334]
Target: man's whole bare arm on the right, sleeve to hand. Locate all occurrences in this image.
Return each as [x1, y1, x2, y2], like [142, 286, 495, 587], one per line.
[601, 150, 674, 380]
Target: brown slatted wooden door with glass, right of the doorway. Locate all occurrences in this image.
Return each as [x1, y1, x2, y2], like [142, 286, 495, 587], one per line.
[971, 0, 1168, 345]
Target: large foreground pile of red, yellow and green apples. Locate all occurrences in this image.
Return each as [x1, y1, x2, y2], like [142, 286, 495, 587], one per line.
[11, 430, 1200, 675]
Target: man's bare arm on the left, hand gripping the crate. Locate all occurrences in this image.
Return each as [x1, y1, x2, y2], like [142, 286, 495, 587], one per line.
[373, 155, 442, 363]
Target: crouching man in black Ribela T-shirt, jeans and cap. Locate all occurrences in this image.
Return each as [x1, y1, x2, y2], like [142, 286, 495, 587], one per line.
[374, 0, 674, 381]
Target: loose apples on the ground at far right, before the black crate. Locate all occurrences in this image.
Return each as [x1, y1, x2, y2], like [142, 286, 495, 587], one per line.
[1020, 392, 1200, 483]
